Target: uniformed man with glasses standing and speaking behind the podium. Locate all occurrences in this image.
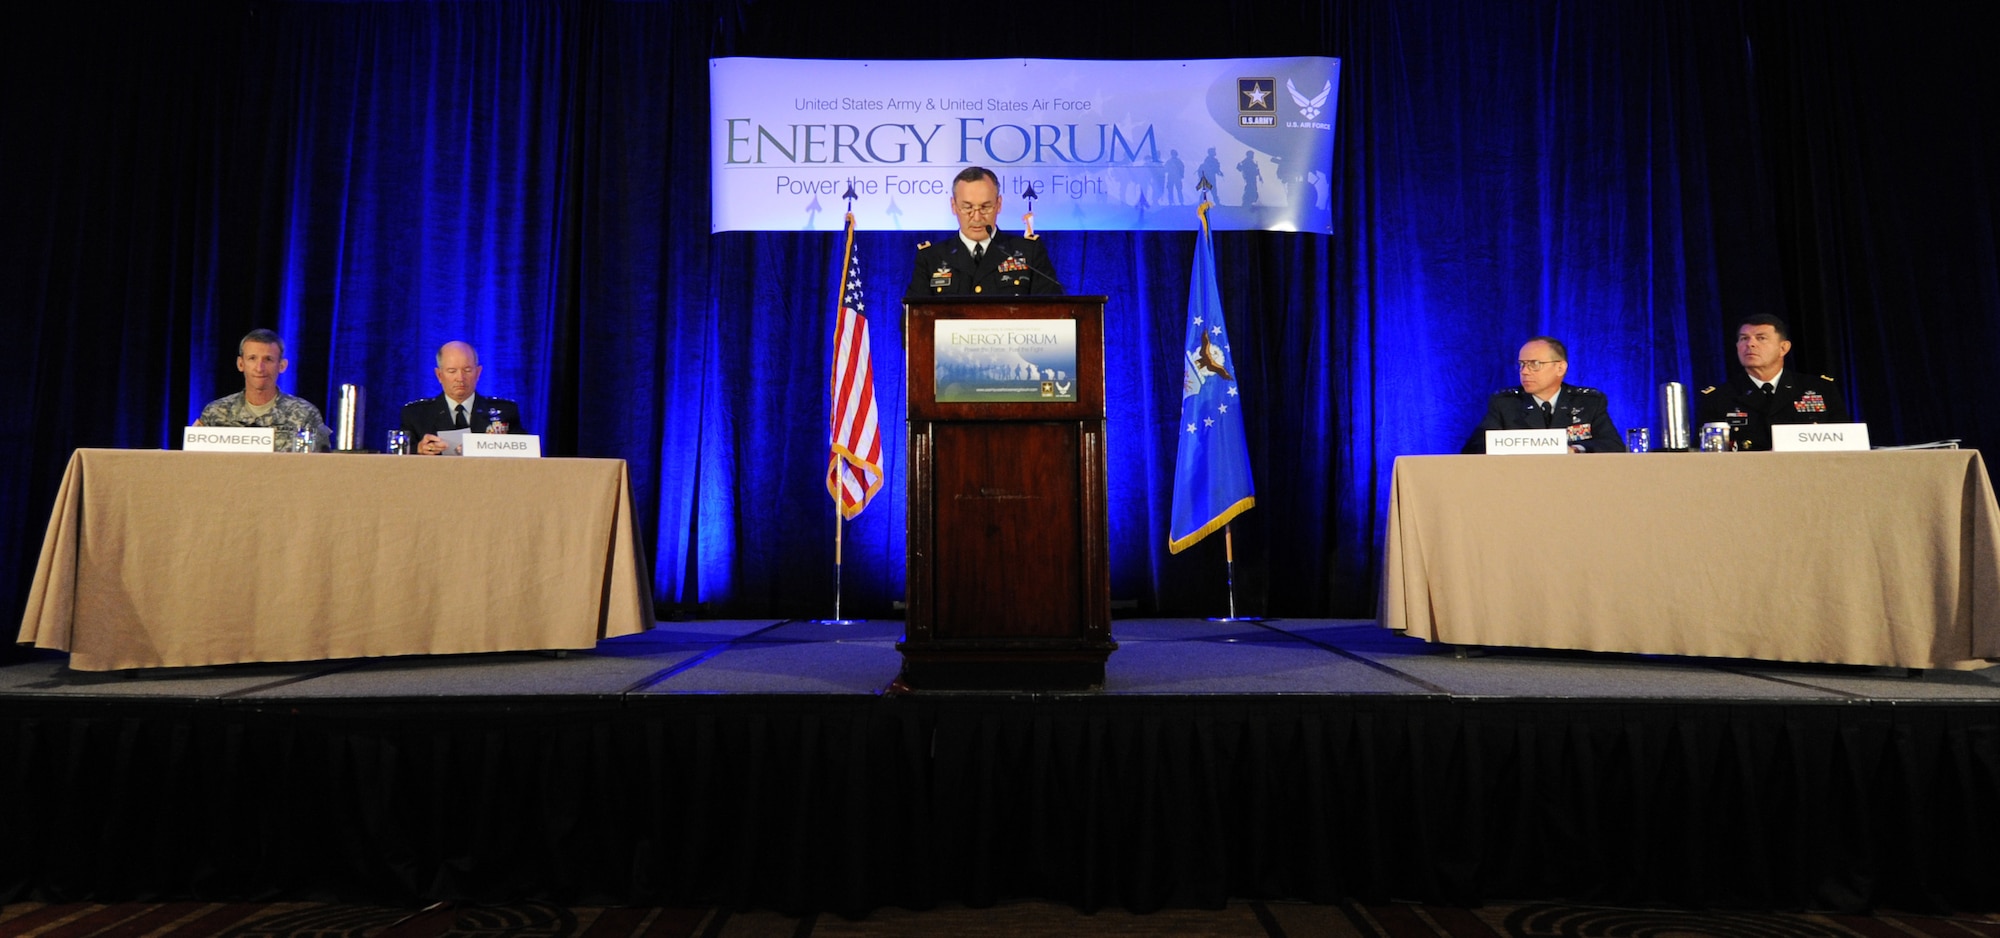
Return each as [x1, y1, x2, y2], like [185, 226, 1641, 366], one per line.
[904, 166, 1064, 300]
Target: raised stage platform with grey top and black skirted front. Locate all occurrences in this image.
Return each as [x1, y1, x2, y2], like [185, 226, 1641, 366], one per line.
[0, 620, 2000, 912]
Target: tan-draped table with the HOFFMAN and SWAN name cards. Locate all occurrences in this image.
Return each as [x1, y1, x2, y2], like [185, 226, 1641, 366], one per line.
[1380, 450, 2000, 668]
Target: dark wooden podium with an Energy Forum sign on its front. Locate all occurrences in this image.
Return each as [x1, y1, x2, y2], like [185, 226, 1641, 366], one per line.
[896, 296, 1118, 690]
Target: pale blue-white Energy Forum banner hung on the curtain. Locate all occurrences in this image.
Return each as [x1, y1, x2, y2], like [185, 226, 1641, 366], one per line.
[708, 56, 1340, 234]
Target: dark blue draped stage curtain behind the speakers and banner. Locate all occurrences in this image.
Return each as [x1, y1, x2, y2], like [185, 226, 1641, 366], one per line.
[0, 0, 2000, 628]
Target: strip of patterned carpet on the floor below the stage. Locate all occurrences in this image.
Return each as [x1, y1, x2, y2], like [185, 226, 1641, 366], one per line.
[0, 902, 2000, 938]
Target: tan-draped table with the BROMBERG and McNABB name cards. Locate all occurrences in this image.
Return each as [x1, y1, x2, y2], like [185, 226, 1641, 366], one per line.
[20, 450, 652, 670]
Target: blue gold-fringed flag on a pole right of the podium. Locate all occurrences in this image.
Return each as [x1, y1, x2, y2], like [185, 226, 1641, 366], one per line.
[1166, 202, 1256, 554]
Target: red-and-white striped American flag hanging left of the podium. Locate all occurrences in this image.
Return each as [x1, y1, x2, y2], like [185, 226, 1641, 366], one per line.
[826, 224, 882, 518]
